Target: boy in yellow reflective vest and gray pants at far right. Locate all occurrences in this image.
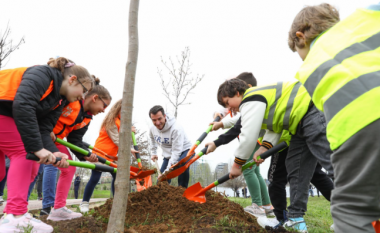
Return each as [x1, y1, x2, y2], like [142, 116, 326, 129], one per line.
[288, 3, 380, 233]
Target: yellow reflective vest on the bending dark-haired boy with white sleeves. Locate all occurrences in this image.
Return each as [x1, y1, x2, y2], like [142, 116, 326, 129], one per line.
[243, 82, 310, 134]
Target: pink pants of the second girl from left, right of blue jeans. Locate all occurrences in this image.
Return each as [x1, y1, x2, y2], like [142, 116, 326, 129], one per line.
[54, 145, 76, 209]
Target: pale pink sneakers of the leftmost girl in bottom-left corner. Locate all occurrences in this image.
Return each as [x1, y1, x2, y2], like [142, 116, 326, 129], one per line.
[0, 213, 53, 233]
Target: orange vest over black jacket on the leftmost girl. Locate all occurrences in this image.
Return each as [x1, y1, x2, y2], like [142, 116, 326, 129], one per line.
[0, 67, 54, 101]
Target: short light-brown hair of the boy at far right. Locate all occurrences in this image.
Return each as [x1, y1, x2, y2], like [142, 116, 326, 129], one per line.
[288, 3, 339, 52]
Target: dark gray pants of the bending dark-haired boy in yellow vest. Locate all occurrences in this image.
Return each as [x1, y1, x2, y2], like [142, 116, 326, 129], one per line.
[285, 106, 334, 218]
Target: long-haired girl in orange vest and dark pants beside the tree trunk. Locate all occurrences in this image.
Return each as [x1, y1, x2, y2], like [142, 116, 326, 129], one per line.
[80, 100, 138, 213]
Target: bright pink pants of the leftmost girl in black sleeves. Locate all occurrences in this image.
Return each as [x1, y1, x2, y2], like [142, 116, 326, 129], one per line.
[0, 115, 40, 215]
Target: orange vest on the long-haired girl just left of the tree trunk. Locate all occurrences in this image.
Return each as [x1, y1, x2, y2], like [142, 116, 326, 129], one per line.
[94, 118, 120, 162]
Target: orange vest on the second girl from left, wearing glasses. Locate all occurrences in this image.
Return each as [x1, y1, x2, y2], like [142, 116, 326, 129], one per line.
[53, 101, 92, 140]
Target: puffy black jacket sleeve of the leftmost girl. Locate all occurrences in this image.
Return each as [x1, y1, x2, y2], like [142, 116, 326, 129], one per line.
[13, 66, 58, 152]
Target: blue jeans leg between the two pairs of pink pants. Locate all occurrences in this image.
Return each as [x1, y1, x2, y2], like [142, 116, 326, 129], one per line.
[42, 164, 58, 209]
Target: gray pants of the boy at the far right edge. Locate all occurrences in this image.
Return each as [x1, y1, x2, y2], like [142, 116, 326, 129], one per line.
[331, 120, 380, 233]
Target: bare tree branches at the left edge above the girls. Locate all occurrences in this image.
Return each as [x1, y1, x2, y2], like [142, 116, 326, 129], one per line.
[0, 23, 25, 70]
